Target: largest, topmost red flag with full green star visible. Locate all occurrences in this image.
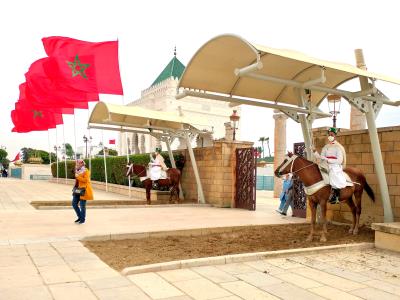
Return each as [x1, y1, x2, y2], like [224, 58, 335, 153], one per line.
[42, 36, 123, 95]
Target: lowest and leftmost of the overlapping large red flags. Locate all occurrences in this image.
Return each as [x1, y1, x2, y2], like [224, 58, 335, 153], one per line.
[11, 102, 63, 132]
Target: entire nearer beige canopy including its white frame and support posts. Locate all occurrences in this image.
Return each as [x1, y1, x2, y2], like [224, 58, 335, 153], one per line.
[176, 35, 400, 222]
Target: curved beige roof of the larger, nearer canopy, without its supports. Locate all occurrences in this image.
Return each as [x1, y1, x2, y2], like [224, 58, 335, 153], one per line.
[179, 35, 400, 106]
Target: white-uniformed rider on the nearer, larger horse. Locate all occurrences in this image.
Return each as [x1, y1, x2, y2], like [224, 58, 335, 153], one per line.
[314, 127, 346, 204]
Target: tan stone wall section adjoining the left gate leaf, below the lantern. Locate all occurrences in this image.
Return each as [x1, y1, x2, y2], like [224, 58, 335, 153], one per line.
[176, 140, 253, 207]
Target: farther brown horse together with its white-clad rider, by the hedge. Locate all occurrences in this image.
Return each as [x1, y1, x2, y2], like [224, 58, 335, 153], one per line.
[126, 148, 181, 204]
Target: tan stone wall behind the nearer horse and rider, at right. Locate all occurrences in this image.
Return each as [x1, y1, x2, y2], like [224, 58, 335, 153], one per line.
[313, 126, 400, 224]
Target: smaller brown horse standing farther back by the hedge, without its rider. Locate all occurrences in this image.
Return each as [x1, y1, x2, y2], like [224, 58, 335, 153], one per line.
[126, 164, 181, 204]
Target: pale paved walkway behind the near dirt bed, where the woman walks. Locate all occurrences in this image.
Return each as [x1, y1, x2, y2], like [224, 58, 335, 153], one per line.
[0, 179, 304, 245]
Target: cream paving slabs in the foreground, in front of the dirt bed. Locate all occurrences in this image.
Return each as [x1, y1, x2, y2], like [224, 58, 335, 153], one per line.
[0, 241, 400, 300]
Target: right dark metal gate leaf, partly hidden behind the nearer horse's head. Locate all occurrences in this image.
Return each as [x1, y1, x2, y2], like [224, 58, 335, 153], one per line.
[293, 143, 307, 218]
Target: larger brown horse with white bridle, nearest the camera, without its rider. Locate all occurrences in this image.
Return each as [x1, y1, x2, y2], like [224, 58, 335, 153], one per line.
[275, 152, 375, 242]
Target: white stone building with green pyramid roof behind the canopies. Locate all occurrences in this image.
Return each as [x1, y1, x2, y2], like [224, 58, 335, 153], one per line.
[117, 54, 240, 155]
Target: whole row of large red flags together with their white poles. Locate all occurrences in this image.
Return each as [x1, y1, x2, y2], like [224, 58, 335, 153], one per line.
[11, 36, 126, 190]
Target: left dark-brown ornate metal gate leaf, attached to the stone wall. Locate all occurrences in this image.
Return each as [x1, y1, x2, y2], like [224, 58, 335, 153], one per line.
[235, 148, 257, 210]
